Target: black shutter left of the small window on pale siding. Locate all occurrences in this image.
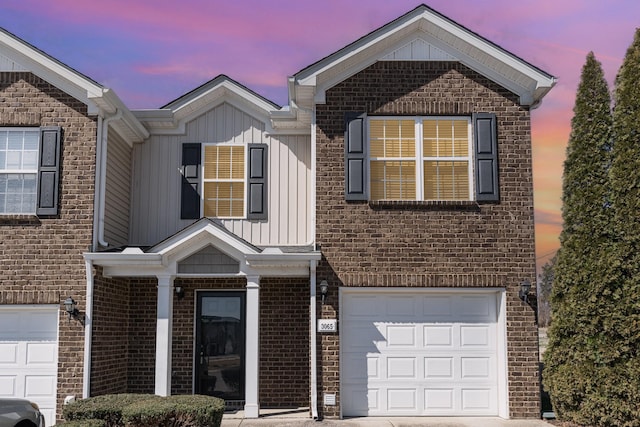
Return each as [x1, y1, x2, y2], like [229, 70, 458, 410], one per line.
[180, 143, 202, 219]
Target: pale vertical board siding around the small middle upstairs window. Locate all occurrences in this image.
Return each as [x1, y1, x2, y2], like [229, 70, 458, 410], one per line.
[130, 103, 312, 246]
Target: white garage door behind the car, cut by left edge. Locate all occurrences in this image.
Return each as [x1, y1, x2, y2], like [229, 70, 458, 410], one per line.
[0, 305, 59, 426]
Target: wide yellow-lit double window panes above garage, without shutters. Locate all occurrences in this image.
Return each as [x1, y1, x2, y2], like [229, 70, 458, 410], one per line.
[368, 117, 472, 200]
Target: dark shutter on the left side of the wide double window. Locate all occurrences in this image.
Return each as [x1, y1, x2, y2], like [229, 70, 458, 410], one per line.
[344, 113, 369, 200]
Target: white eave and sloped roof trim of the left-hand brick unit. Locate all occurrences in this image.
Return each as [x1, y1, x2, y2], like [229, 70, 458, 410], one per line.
[0, 28, 147, 141]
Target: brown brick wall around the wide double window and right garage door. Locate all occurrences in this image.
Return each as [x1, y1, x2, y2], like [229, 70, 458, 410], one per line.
[316, 61, 540, 418]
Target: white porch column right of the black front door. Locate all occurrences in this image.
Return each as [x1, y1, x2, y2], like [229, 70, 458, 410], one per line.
[244, 276, 260, 418]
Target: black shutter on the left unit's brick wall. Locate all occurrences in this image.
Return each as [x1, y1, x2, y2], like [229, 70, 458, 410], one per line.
[36, 126, 62, 215]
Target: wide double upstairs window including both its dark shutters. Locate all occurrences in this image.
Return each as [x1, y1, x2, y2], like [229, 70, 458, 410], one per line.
[345, 113, 499, 202]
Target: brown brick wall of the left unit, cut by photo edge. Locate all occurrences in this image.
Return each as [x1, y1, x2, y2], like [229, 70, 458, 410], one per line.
[0, 72, 96, 417]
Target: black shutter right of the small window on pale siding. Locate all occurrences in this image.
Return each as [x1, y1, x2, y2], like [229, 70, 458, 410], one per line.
[247, 144, 268, 219]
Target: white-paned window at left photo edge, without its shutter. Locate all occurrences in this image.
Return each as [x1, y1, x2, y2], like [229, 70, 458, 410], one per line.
[0, 128, 40, 214]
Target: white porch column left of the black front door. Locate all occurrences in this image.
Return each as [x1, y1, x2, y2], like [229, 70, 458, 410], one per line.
[155, 276, 174, 396]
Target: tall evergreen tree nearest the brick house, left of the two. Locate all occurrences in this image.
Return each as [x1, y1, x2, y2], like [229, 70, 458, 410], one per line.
[543, 52, 612, 425]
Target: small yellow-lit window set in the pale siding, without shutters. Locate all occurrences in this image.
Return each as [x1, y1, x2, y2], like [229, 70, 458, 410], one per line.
[203, 144, 246, 218]
